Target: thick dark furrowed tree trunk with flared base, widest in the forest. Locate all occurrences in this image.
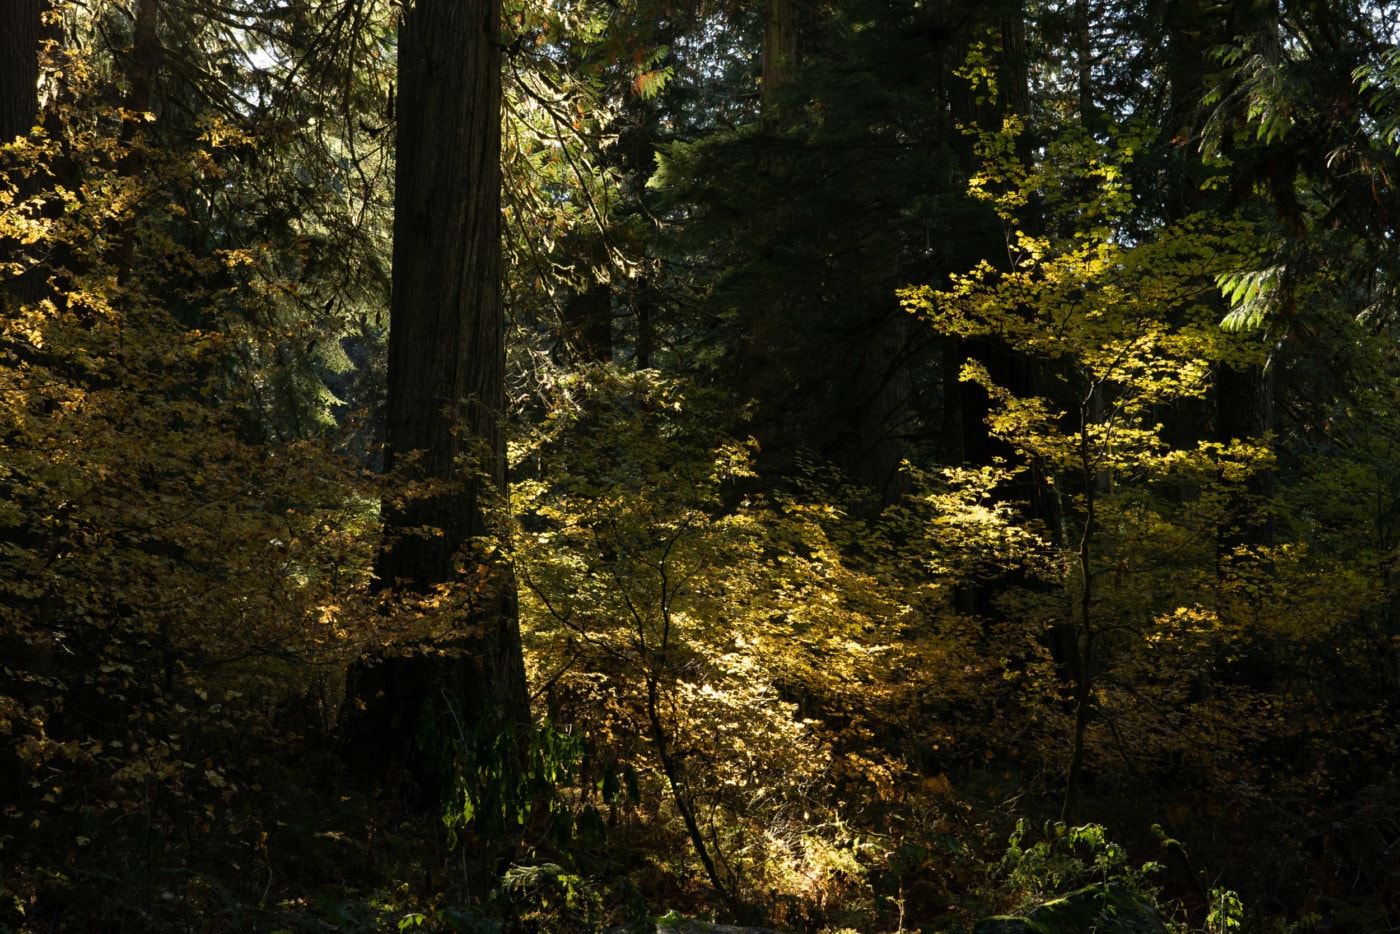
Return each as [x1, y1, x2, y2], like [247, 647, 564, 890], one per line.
[344, 0, 529, 807]
